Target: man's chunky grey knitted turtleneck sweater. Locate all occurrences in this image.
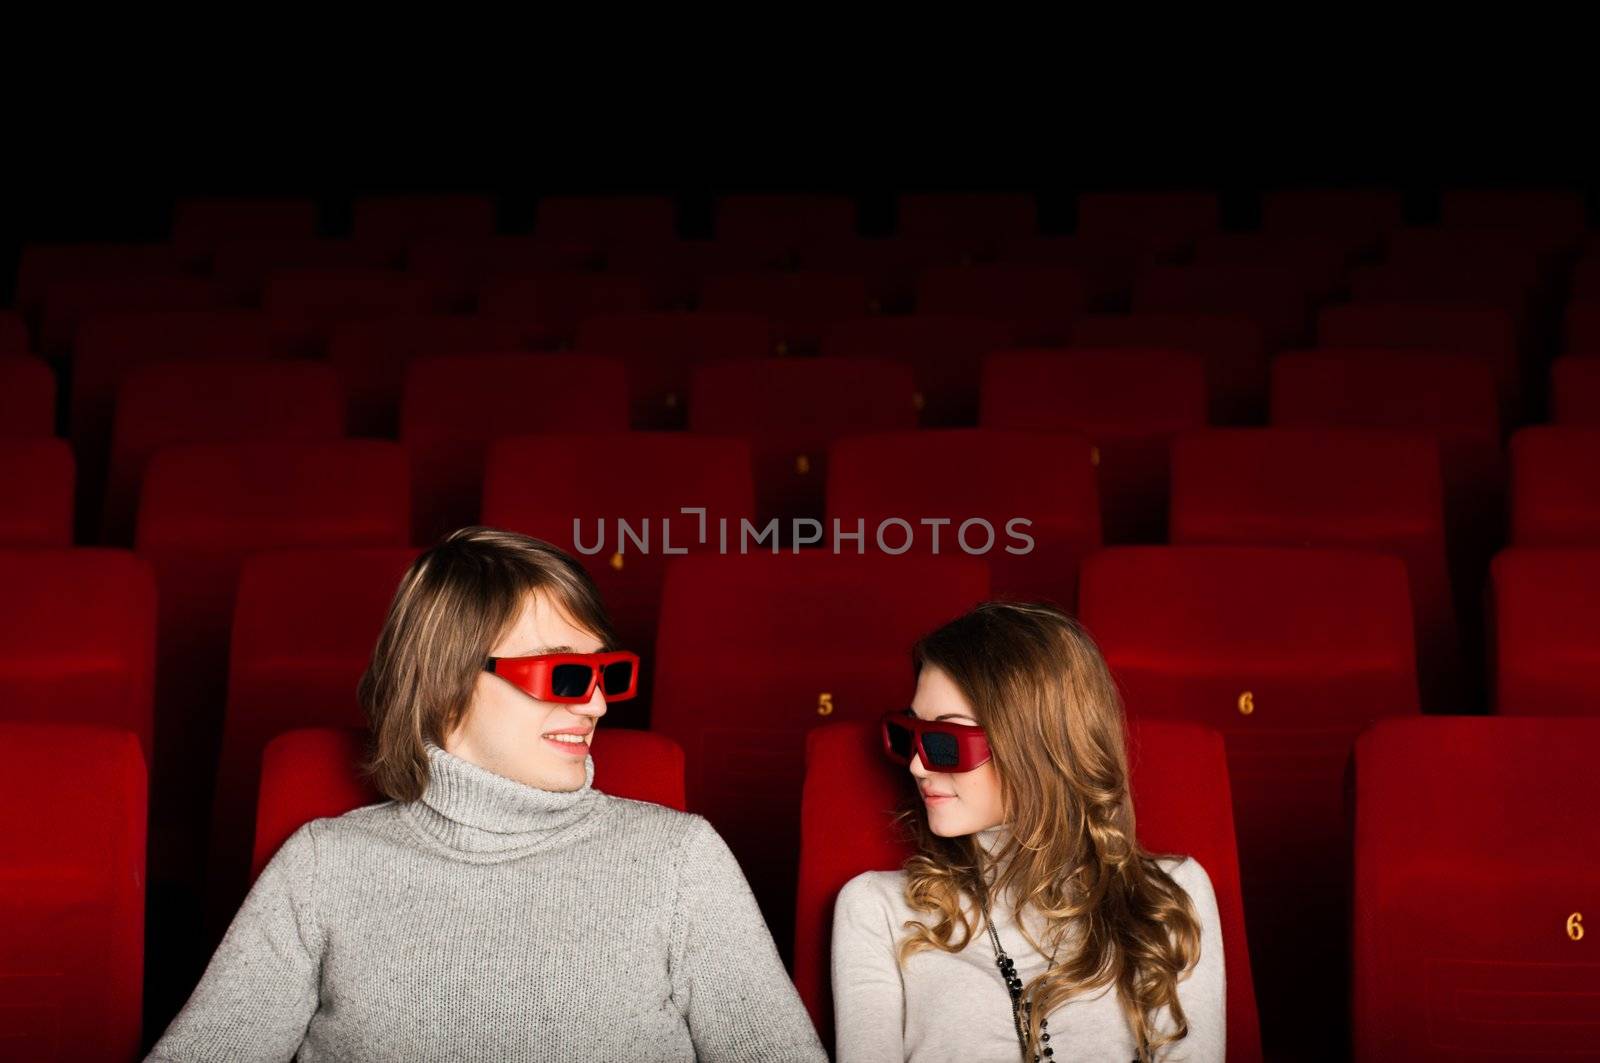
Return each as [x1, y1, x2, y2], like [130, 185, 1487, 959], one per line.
[147, 735, 827, 1063]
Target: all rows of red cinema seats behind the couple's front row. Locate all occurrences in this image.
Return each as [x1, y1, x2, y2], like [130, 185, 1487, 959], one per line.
[0, 192, 1600, 1055]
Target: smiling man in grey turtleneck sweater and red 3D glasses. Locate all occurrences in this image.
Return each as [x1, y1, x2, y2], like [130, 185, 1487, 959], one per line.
[149, 527, 827, 1063]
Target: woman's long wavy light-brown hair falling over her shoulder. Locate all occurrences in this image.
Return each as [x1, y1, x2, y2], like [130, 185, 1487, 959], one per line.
[899, 602, 1200, 1061]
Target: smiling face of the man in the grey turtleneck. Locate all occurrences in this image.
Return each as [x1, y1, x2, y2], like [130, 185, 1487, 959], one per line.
[443, 592, 606, 791]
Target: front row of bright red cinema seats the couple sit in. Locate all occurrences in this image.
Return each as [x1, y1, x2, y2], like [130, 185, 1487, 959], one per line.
[0, 704, 1600, 1061]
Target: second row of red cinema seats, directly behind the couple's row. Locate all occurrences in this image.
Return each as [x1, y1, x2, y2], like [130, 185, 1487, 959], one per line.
[0, 534, 1600, 1056]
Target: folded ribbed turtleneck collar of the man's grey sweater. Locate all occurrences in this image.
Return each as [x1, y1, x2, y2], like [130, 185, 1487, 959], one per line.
[405, 741, 600, 863]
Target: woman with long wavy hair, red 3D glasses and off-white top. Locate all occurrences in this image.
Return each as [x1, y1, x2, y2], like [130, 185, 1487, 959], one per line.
[834, 602, 1226, 1063]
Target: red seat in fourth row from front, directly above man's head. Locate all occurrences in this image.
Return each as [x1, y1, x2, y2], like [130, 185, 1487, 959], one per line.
[400, 354, 627, 546]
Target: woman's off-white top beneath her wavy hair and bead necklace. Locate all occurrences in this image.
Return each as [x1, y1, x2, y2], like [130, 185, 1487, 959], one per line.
[834, 824, 1227, 1063]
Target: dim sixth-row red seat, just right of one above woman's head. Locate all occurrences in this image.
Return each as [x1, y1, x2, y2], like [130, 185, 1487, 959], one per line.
[1133, 263, 1314, 348]
